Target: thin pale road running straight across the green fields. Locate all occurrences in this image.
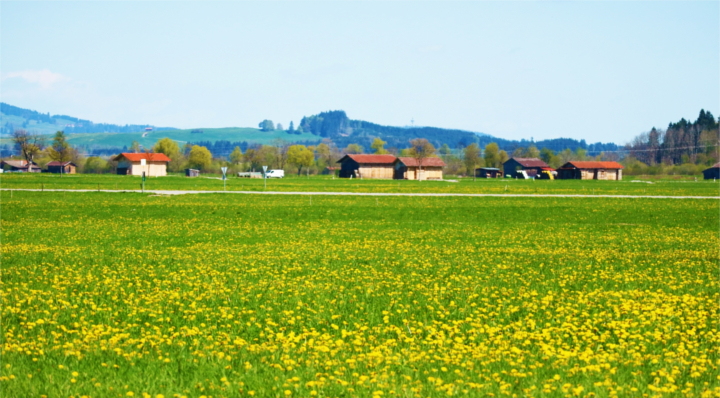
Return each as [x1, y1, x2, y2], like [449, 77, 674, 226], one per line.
[2, 188, 720, 200]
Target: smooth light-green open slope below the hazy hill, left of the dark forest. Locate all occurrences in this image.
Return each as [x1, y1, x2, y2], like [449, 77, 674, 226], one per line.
[0, 127, 320, 148]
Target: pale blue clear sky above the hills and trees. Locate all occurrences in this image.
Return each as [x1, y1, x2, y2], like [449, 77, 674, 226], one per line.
[0, 1, 720, 144]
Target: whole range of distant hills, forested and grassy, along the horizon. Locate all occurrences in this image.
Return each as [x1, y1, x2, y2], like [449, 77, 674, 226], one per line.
[0, 103, 618, 156]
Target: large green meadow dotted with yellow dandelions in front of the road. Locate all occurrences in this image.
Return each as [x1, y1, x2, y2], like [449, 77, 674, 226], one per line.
[0, 190, 720, 397]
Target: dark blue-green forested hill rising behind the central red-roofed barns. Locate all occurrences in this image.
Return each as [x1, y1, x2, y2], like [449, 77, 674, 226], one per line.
[297, 111, 618, 153]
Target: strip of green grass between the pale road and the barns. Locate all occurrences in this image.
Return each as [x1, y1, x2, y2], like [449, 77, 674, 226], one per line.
[0, 173, 720, 196]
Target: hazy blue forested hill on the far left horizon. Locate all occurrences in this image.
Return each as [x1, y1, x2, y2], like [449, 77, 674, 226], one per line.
[0, 102, 175, 135]
